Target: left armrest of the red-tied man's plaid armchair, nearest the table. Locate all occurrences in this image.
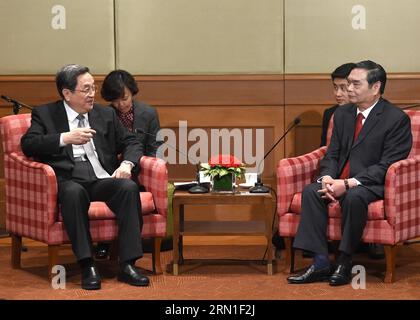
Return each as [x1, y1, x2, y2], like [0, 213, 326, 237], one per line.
[277, 147, 327, 216]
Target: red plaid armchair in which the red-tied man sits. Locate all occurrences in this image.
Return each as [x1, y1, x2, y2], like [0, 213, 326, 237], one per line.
[277, 110, 420, 283]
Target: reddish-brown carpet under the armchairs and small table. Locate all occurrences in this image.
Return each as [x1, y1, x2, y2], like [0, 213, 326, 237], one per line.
[0, 243, 420, 300]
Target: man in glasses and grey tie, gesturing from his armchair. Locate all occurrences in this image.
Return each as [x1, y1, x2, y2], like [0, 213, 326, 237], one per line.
[21, 64, 149, 290]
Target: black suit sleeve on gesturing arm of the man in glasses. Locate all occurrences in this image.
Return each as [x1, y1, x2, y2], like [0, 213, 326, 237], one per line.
[20, 108, 61, 157]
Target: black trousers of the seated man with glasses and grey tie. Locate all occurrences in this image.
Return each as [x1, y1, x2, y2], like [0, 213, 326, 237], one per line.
[58, 161, 143, 261]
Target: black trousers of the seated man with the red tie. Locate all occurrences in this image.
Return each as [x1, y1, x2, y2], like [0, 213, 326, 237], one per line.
[293, 183, 379, 255]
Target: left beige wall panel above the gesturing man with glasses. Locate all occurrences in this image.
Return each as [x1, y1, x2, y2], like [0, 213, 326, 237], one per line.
[0, 0, 115, 74]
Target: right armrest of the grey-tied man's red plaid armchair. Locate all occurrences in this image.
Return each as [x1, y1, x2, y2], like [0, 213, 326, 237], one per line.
[138, 156, 168, 217]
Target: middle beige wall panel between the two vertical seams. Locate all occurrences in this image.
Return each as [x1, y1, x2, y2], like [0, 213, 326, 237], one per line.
[115, 0, 283, 74]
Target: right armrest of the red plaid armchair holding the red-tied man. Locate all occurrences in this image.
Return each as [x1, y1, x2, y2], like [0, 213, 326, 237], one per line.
[384, 156, 420, 242]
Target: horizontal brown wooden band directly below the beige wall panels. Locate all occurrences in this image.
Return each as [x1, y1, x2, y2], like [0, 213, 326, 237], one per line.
[0, 73, 420, 107]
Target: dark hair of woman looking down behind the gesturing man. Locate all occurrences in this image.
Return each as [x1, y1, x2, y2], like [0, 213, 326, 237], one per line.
[101, 70, 139, 101]
